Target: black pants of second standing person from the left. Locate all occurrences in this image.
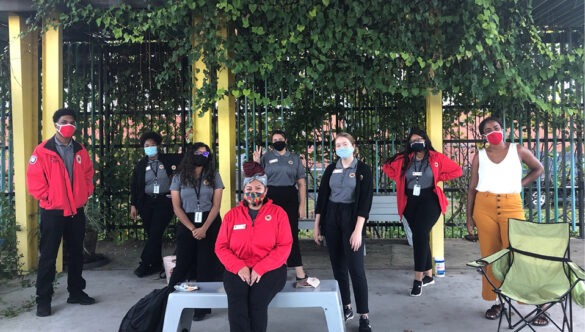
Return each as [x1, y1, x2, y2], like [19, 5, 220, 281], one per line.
[139, 195, 173, 268]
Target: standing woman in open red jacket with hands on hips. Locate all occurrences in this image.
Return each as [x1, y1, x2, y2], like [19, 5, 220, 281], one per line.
[382, 129, 462, 296]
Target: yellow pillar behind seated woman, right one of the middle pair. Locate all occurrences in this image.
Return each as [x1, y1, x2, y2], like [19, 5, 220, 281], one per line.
[217, 28, 236, 216]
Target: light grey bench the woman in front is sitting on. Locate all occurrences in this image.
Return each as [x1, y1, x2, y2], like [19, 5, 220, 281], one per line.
[163, 280, 345, 332]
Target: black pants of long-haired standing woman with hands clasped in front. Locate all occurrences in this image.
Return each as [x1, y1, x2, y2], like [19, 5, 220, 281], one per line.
[169, 212, 223, 286]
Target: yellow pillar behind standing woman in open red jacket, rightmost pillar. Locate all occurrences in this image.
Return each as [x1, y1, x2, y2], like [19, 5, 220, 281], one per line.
[426, 89, 445, 273]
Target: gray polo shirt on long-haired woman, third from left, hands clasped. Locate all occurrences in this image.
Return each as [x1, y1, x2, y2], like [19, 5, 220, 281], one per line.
[171, 172, 224, 213]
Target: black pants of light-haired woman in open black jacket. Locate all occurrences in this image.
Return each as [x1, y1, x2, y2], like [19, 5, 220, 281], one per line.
[325, 201, 369, 314]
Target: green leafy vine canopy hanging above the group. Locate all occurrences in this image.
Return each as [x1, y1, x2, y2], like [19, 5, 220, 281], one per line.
[35, 0, 584, 113]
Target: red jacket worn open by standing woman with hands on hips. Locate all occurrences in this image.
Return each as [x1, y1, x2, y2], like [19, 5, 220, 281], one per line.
[382, 151, 463, 218]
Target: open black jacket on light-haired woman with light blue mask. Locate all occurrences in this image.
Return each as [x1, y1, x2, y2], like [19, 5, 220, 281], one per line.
[315, 160, 374, 234]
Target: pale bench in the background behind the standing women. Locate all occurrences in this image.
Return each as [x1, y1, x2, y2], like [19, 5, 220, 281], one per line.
[299, 194, 412, 245]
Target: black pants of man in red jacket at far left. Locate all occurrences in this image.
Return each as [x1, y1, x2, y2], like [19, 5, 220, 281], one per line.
[36, 208, 85, 302]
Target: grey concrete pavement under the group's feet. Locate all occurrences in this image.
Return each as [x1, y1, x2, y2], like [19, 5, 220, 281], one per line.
[0, 240, 585, 332]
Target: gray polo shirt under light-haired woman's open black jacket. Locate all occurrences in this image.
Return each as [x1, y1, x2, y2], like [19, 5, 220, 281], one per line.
[329, 158, 357, 203]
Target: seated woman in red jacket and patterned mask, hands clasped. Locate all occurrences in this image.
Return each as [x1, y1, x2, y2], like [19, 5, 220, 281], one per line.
[215, 162, 292, 332]
